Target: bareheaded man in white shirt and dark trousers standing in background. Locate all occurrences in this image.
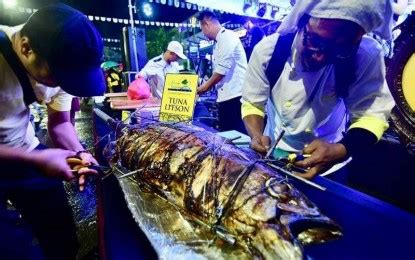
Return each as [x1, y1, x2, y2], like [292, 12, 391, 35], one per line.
[197, 11, 247, 133]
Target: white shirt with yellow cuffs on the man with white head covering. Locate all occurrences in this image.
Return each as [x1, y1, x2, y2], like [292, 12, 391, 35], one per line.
[242, 33, 395, 151]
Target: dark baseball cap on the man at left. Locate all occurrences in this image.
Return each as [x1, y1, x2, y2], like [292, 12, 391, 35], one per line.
[22, 3, 105, 97]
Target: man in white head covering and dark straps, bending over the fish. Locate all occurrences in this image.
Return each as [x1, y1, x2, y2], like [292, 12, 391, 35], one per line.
[242, 0, 394, 178]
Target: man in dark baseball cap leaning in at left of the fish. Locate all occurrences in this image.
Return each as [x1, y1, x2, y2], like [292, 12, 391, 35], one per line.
[0, 4, 105, 259]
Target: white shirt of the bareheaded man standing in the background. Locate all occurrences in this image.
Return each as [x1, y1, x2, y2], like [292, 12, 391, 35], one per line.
[213, 27, 248, 102]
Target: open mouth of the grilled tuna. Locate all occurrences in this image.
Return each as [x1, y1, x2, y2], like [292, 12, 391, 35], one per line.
[288, 216, 343, 245]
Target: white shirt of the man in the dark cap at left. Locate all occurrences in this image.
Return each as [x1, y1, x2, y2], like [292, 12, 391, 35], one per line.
[0, 26, 73, 151]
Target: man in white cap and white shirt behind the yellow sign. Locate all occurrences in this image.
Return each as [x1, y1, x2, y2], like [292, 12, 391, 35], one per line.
[135, 41, 187, 99]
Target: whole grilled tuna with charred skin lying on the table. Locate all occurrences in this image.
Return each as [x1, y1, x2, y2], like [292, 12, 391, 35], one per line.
[113, 123, 341, 259]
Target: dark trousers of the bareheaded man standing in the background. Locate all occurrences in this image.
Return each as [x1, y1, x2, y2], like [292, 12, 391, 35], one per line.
[218, 97, 246, 134]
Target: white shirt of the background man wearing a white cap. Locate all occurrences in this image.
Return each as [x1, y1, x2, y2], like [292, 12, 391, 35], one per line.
[138, 54, 180, 99]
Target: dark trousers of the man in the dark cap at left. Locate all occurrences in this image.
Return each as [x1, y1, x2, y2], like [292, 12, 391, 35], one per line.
[0, 146, 79, 259]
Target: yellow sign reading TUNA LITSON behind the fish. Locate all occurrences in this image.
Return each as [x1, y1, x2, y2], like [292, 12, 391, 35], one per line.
[160, 73, 198, 122]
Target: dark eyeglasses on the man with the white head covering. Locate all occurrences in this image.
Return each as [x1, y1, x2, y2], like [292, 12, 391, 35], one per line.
[303, 26, 360, 59]
